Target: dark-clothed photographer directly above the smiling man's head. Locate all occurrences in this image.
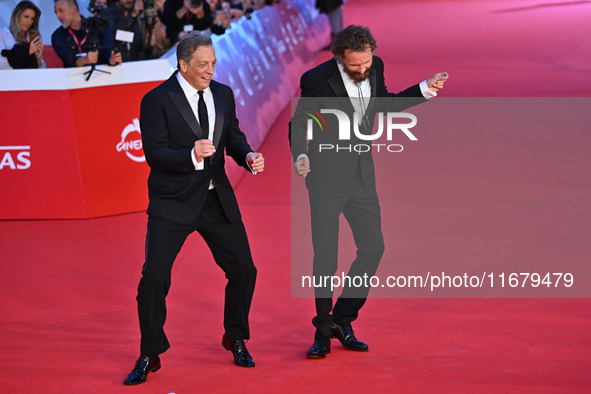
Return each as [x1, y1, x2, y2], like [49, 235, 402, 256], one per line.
[162, 0, 225, 44]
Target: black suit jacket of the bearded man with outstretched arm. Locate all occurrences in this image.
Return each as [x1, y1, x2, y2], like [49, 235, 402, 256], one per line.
[289, 56, 425, 195]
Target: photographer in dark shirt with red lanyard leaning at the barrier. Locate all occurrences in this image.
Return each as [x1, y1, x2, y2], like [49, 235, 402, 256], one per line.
[51, 0, 122, 68]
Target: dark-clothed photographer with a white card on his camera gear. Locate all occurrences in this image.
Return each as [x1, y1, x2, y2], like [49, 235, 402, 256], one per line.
[100, 0, 145, 62]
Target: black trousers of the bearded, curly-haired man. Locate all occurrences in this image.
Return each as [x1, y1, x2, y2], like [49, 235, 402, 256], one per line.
[309, 174, 384, 339]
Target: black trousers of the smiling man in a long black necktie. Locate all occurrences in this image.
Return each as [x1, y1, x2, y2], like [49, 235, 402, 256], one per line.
[137, 190, 257, 356]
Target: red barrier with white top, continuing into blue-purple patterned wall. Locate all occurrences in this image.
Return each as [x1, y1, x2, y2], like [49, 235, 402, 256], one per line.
[0, 0, 329, 219]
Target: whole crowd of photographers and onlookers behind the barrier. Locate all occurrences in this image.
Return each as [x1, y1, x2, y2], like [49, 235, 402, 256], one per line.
[0, 0, 278, 69]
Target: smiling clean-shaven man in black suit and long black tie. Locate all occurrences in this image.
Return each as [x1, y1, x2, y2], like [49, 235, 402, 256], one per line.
[125, 32, 264, 385]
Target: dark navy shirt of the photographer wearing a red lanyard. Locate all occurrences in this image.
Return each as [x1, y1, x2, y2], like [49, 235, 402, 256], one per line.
[51, 17, 113, 68]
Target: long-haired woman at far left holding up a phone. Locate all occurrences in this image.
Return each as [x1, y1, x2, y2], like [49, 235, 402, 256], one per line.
[0, 1, 43, 70]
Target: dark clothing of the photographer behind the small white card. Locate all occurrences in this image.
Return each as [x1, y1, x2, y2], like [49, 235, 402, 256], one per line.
[100, 3, 145, 62]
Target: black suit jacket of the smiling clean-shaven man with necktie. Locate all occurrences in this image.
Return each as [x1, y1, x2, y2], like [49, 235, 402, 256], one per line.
[140, 71, 252, 224]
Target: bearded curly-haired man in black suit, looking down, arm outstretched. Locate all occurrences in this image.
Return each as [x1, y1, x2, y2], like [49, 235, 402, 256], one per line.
[290, 25, 447, 358]
